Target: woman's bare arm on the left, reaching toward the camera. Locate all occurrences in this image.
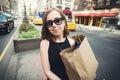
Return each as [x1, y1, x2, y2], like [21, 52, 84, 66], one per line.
[40, 40, 61, 80]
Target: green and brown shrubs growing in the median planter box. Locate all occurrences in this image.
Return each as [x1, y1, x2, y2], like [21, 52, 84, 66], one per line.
[18, 23, 40, 39]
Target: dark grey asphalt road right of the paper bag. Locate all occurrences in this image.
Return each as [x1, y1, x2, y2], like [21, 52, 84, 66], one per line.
[71, 29, 120, 80]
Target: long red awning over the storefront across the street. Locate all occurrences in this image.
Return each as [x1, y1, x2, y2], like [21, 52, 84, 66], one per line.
[74, 13, 118, 17]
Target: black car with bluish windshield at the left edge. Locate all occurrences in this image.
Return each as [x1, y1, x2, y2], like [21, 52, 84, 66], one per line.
[0, 13, 14, 34]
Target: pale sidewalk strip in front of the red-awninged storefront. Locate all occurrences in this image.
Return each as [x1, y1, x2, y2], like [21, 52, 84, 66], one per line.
[77, 24, 120, 34]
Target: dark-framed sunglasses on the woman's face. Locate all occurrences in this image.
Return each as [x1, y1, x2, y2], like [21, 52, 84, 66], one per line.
[46, 18, 65, 28]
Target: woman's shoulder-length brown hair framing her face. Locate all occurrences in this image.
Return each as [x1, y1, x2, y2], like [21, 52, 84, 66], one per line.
[41, 8, 69, 40]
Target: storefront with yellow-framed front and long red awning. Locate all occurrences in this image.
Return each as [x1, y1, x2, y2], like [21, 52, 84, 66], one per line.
[73, 11, 118, 26]
